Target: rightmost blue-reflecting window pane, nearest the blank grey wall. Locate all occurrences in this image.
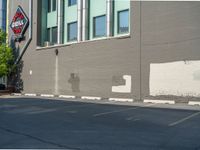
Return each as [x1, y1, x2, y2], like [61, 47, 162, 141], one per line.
[118, 10, 129, 34]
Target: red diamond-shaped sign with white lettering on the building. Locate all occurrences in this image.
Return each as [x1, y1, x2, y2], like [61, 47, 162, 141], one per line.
[10, 6, 29, 38]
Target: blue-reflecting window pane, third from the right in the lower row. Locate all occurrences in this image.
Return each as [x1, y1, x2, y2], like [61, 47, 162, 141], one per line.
[67, 22, 77, 42]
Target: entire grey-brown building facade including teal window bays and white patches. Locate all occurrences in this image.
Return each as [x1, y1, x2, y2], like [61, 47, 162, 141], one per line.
[9, 0, 200, 100]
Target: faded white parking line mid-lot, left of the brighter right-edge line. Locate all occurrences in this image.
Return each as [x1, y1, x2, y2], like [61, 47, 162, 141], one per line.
[93, 104, 156, 117]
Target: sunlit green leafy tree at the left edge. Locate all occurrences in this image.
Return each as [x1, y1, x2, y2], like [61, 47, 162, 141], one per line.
[0, 29, 14, 77]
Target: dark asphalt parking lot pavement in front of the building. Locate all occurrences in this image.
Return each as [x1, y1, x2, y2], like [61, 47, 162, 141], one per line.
[0, 97, 200, 150]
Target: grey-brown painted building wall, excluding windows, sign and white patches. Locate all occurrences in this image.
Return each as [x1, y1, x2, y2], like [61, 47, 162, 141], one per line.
[10, 0, 200, 100]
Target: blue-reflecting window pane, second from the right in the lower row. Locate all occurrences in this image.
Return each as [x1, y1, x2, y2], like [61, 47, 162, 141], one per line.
[93, 15, 106, 37]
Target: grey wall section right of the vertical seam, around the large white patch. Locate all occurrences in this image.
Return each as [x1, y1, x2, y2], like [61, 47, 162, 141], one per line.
[141, 1, 200, 98]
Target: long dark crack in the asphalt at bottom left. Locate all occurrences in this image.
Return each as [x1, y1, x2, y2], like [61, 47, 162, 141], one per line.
[0, 127, 80, 150]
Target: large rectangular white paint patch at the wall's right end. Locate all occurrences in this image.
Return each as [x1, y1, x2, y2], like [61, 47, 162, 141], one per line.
[149, 61, 200, 97]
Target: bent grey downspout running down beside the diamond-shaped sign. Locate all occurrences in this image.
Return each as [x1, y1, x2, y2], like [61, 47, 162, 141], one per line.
[15, 0, 33, 64]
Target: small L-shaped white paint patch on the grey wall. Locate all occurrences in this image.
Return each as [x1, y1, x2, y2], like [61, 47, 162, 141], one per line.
[112, 75, 131, 93]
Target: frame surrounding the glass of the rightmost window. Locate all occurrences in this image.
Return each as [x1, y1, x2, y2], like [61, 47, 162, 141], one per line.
[117, 9, 130, 35]
